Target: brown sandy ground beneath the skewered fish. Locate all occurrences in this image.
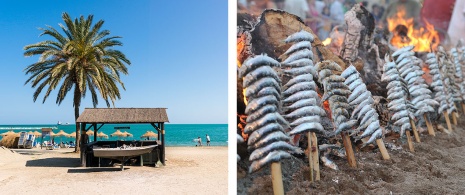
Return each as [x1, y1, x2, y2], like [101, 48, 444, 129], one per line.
[237, 114, 465, 194]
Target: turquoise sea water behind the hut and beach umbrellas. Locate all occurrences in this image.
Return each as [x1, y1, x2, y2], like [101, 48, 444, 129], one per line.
[0, 123, 228, 146]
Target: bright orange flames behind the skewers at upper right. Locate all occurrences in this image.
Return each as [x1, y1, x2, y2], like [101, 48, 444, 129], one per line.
[387, 9, 439, 52]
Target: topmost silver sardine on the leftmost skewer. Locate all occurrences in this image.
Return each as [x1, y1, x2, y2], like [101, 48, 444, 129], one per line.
[238, 54, 281, 77]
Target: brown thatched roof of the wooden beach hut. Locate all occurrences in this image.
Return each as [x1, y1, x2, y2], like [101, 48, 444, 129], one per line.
[76, 108, 169, 123]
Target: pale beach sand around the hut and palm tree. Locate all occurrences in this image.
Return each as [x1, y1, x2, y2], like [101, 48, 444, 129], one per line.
[0, 147, 228, 194]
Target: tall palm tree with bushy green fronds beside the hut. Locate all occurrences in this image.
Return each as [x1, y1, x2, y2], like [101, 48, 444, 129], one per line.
[24, 12, 131, 152]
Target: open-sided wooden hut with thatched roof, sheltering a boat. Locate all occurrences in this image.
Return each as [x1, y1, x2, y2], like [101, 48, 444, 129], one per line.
[76, 108, 169, 167]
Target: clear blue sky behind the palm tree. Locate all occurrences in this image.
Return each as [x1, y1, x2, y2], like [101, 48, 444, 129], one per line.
[0, 0, 228, 124]
